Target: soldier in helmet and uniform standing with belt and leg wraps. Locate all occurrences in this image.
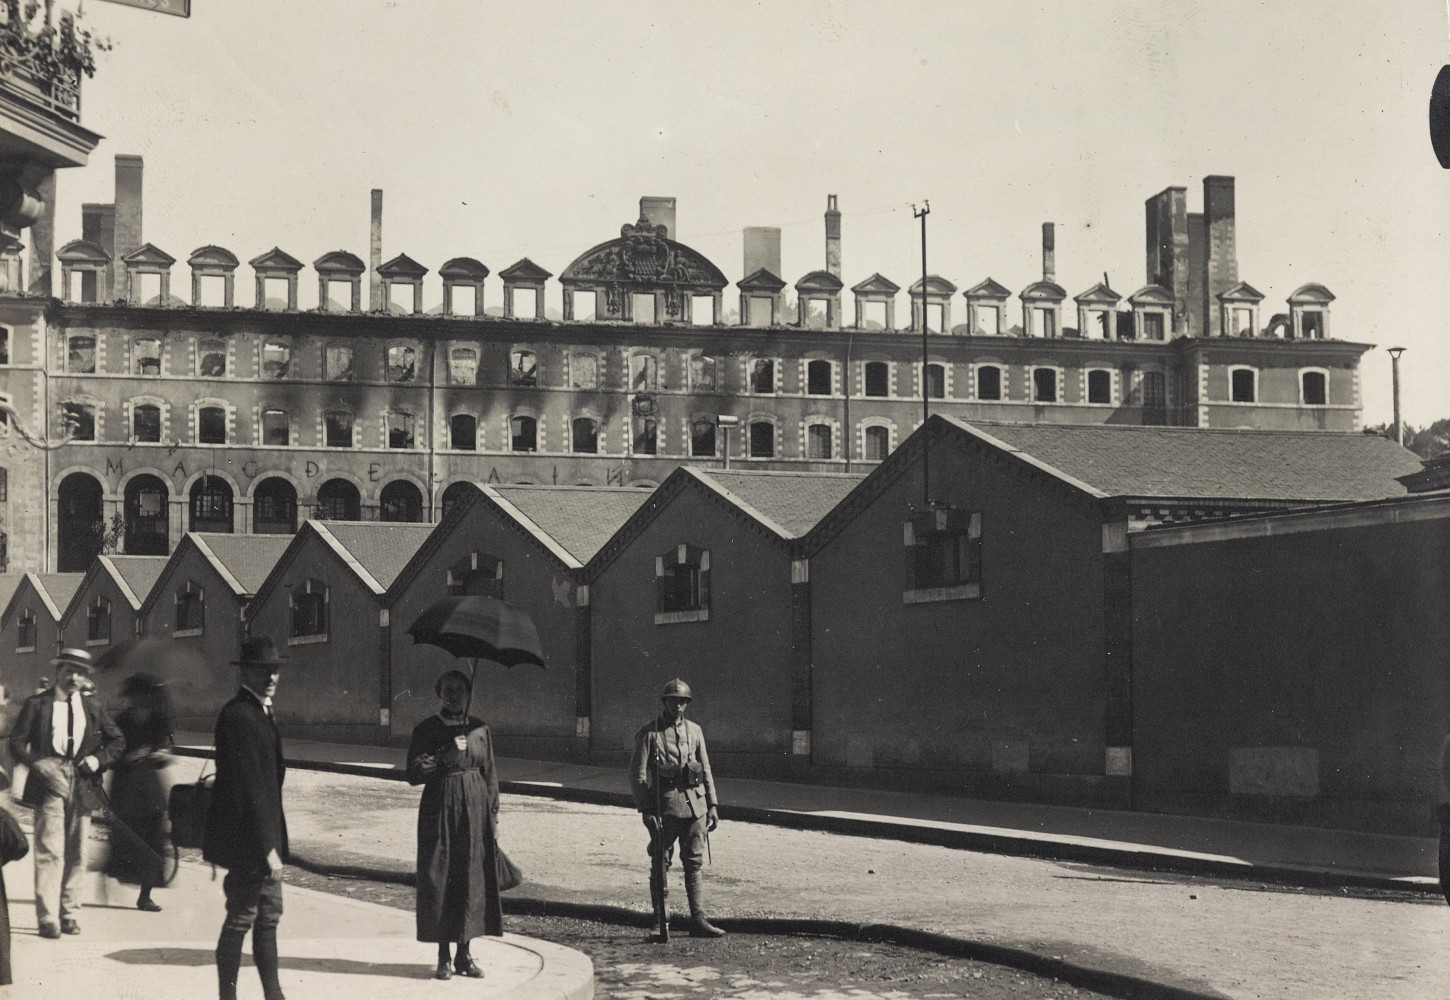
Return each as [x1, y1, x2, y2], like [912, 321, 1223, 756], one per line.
[629, 678, 725, 938]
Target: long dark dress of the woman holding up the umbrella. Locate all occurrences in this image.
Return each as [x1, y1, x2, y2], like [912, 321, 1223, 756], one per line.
[407, 716, 503, 942]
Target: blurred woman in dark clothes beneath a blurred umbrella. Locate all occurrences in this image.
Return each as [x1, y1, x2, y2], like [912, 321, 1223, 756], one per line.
[106, 674, 175, 913]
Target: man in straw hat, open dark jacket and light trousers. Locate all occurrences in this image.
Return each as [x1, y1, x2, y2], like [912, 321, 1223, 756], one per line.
[10, 649, 125, 938]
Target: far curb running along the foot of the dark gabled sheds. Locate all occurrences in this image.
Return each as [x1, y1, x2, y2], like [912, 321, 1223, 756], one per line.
[175, 748, 1440, 896]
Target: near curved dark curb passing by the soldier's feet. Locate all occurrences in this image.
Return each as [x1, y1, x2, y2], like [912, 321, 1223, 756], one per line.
[287, 854, 1222, 1000]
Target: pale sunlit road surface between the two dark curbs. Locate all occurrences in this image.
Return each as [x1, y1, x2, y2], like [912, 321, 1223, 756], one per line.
[274, 771, 1450, 1000]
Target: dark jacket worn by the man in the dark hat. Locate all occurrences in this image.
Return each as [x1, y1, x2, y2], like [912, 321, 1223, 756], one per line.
[202, 690, 287, 871]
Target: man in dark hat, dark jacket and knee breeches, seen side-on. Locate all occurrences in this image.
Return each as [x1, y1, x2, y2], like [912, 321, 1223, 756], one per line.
[202, 636, 287, 1000]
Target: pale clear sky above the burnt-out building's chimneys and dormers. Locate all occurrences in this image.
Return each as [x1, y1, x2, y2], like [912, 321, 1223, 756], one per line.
[42, 0, 1450, 426]
